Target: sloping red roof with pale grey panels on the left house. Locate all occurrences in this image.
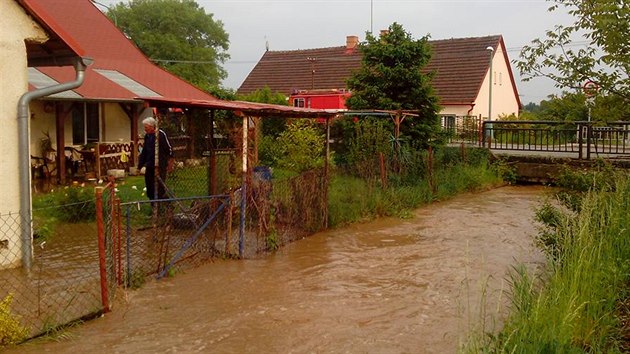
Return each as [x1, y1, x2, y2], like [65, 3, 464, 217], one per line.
[25, 0, 215, 101]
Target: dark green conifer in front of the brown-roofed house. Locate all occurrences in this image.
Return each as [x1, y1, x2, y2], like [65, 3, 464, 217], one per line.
[346, 23, 439, 147]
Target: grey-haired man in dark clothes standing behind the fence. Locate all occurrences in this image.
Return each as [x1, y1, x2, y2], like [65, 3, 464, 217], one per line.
[138, 117, 174, 200]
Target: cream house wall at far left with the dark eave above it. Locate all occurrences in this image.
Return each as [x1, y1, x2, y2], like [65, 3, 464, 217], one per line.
[0, 1, 81, 269]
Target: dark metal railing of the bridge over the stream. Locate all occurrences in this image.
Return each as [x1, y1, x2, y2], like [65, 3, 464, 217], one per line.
[486, 121, 630, 159]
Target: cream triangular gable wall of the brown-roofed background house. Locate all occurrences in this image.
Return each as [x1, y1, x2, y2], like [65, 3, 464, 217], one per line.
[471, 46, 519, 120]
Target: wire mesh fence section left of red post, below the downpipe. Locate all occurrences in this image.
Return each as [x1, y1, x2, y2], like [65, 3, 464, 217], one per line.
[0, 198, 103, 344]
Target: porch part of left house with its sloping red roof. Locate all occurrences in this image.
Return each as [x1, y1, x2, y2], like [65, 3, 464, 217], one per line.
[26, 0, 222, 183]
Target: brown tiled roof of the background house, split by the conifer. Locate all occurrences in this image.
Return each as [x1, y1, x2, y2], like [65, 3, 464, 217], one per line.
[238, 35, 518, 104]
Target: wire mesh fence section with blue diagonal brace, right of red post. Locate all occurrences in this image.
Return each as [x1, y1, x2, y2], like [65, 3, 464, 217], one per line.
[111, 195, 238, 288]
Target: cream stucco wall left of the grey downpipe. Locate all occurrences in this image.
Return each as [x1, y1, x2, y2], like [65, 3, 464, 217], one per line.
[0, 0, 47, 268]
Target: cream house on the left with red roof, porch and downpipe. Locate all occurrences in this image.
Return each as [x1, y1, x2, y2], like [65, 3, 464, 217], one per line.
[0, 0, 336, 269]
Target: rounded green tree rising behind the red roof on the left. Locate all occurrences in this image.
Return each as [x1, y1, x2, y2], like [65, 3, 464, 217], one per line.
[108, 0, 229, 90]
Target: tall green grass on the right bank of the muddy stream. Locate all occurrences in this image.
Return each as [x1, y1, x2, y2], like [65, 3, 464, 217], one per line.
[466, 172, 630, 353]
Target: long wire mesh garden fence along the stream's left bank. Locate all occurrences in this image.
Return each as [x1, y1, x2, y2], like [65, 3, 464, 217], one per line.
[0, 112, 496, 344]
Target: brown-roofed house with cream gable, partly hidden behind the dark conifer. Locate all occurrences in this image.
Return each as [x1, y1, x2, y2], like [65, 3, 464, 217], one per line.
[237, 35, 521, 119]
